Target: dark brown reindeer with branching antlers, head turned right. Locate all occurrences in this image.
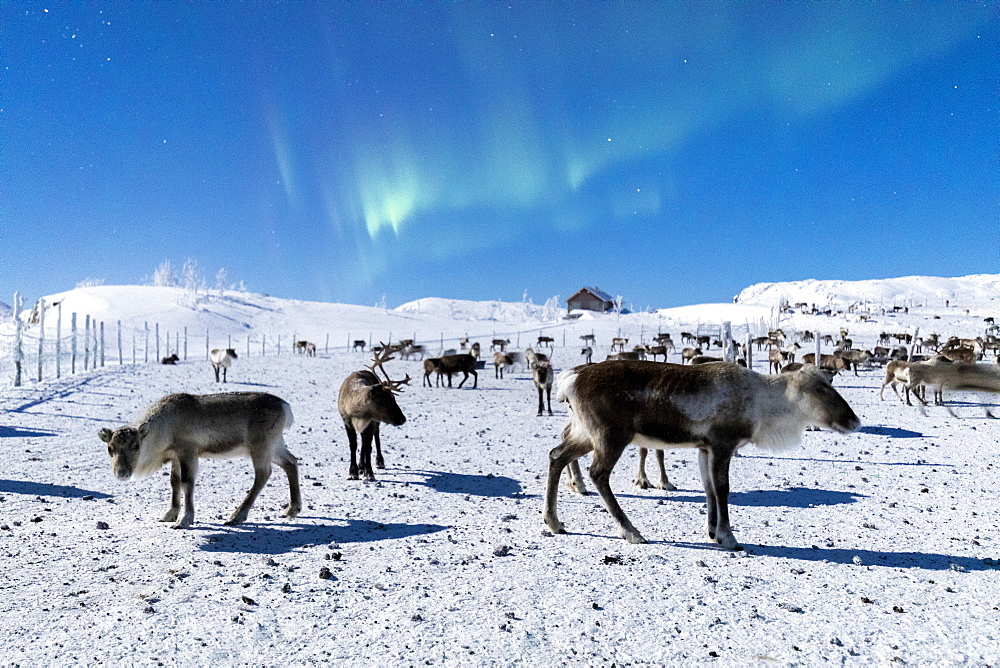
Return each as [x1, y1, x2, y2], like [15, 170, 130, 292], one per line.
[337, 344, 410, 482]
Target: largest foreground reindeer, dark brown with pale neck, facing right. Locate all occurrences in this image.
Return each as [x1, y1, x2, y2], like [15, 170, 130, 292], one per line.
[544, 362, 861, 550]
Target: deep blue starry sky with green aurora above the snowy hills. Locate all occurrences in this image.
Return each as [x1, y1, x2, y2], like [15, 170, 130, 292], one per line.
[0, 1, 1000, 309]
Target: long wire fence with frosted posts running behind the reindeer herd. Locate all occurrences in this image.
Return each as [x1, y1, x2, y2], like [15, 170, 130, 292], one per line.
[0, 295, 767, 387]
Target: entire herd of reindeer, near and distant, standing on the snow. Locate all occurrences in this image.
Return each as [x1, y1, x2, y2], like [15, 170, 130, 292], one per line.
[99, 316, 1000, 550]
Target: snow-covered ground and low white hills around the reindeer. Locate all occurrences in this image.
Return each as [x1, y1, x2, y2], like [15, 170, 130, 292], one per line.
[0, 277, 1000, 665]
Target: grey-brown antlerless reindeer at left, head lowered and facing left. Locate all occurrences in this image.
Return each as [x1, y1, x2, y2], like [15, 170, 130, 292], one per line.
[98, 392, 302, 529]
